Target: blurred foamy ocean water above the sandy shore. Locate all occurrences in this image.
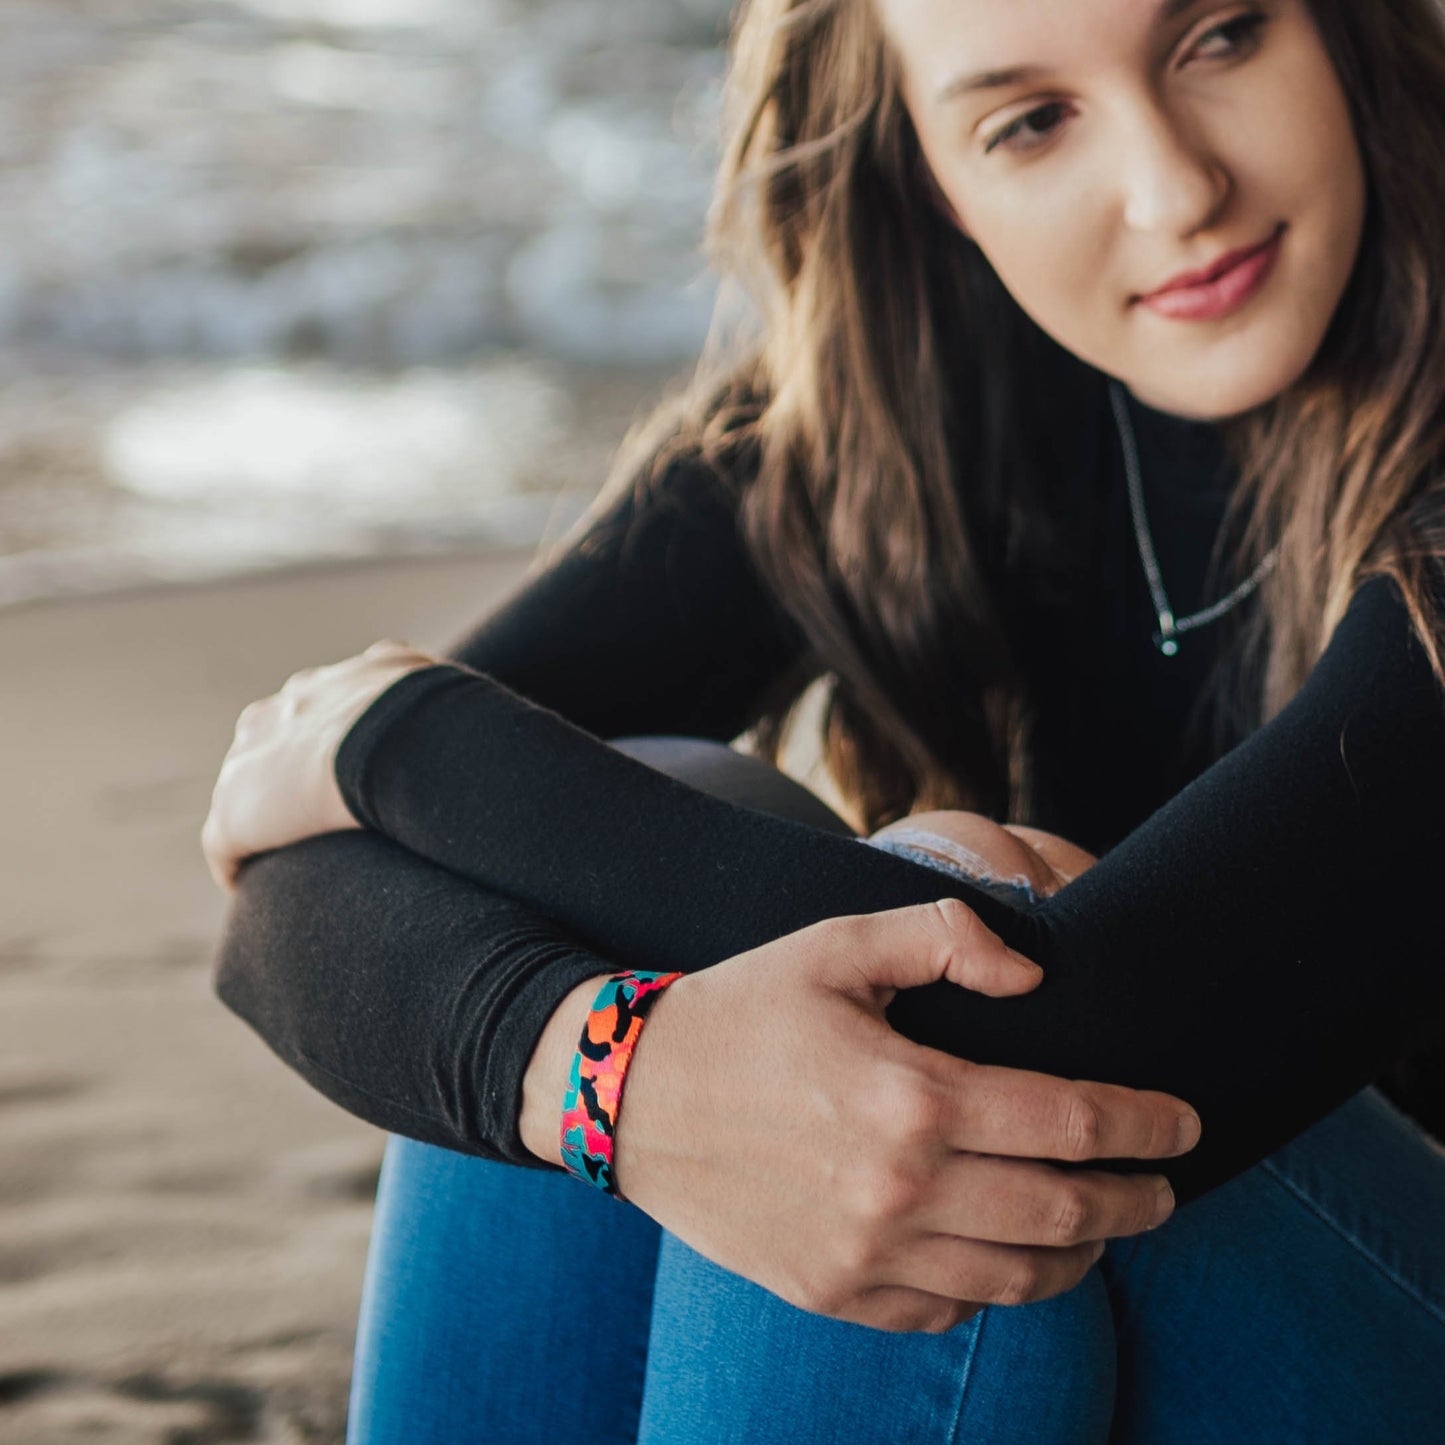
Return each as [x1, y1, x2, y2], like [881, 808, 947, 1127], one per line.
[0, 0, 728, 604]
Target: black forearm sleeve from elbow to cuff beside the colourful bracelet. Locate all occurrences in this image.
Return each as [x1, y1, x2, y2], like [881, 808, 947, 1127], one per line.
[217, 832, 614, 1169]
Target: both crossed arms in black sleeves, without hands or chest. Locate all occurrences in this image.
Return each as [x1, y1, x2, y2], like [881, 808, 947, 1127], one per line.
[220, 456, 1445, 1198]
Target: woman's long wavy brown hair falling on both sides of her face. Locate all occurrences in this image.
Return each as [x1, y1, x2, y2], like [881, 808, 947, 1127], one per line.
[560, 0, 1445, 829]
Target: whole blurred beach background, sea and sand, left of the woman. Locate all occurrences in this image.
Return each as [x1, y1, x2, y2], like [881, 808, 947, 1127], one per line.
[0, 0, 730, 1445]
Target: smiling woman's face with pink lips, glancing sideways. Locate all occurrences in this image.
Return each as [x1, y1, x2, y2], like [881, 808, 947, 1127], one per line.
[873, 0, 1366, 419]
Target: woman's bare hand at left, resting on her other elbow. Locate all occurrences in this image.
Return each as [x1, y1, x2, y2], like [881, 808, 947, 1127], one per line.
[201, 642, 438, 892]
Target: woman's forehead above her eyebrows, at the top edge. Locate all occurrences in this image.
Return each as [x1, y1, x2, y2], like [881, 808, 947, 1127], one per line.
[873, 0, 1207, 98]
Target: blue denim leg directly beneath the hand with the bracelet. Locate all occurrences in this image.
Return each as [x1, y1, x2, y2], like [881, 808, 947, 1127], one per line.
[640, 1233, 1117, 1445]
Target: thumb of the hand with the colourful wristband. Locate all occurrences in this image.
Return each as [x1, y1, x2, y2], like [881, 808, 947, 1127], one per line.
[822, 897, 1043, 1009]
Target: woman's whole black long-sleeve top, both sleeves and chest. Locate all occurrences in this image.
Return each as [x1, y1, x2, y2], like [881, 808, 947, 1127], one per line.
[217, 369, 1445, 1201]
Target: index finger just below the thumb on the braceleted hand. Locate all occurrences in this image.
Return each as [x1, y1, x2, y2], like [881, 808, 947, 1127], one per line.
[945, 1059, 1199, 1162]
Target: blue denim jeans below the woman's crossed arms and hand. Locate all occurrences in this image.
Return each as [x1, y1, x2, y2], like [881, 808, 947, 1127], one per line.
[335, 760, 1445, 1445]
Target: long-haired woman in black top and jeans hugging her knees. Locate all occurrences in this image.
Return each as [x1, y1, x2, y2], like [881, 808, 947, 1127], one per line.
[207, 0, 1445, 1441]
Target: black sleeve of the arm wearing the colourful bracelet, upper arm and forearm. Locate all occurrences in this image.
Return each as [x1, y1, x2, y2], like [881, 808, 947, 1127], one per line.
[215, 460, 806, 1168]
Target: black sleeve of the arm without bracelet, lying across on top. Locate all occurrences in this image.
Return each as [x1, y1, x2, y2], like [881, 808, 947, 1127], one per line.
[328, 578, 1445, 1199]
